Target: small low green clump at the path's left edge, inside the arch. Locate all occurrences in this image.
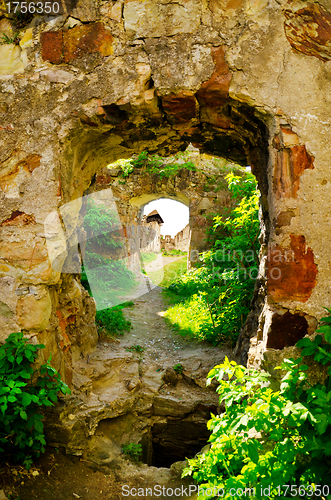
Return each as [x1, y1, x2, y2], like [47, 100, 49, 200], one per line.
[95, 302, 133, 337]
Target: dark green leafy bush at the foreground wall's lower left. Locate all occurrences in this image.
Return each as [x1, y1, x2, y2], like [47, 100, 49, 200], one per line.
[0, 332, 70, 468]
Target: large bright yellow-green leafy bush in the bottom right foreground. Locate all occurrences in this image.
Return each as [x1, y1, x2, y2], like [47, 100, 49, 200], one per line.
[183, 310, 331, 500]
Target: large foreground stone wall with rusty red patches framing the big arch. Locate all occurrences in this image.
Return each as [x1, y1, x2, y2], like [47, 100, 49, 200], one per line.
[0, 0, 331, 383]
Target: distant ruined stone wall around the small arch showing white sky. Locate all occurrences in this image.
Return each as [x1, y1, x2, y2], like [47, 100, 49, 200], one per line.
[86, 153, 240, 265]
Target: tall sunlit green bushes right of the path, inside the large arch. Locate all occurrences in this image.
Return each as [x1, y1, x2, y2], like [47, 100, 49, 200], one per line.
[165, 171, 260, 344]
